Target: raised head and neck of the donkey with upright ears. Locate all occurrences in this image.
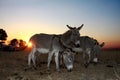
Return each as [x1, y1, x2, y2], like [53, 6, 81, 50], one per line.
[61, 24, 83, 47]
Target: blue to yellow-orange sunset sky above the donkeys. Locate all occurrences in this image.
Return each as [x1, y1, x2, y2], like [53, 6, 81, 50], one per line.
[0, 0, 120, 47]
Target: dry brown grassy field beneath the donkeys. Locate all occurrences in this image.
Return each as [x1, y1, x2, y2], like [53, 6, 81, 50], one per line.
[0, 49, 120, 80]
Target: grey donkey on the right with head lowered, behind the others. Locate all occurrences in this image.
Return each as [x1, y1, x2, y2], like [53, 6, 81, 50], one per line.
[72, 36, 105, 67]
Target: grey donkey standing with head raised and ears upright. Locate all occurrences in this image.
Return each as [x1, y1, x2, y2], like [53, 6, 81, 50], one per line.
[28, 24, 83, 71]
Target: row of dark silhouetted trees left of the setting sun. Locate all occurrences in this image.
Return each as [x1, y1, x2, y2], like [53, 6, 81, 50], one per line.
[0, 29, 26, 51]
